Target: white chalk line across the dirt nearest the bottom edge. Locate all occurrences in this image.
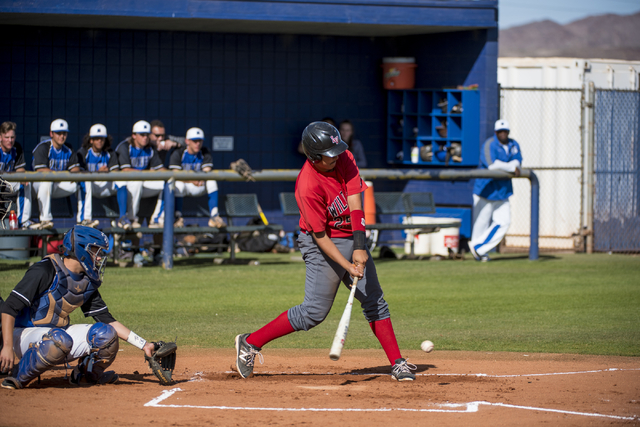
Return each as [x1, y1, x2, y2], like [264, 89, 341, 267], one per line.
[144, 388, 638, 421]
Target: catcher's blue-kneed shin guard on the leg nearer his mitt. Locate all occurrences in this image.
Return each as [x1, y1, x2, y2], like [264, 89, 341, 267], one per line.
[71, 322, 120, 384]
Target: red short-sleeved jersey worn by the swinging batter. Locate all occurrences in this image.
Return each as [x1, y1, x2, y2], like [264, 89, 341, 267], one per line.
[296, 151, 367, 237]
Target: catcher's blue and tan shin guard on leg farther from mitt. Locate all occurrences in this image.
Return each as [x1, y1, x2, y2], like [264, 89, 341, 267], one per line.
[15, 328, 73, 387]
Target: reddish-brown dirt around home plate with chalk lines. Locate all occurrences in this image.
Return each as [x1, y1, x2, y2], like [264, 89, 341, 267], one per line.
[0, 348, 640, 427]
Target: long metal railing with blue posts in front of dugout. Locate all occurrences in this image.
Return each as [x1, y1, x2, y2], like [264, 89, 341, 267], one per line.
[4, 169, 540, 270]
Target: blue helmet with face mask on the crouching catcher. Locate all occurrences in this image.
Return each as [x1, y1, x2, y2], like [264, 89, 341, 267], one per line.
[61, 225, 109, 281]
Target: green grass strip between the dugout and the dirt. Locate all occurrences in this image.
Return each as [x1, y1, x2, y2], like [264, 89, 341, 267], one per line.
[0, 254, 640, 356]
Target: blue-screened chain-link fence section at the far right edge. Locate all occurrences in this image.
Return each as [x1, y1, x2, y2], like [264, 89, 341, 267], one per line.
[593, 89, 640, 253]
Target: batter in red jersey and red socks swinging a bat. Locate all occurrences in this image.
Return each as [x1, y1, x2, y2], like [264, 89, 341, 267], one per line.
[235, 122, 416, 381]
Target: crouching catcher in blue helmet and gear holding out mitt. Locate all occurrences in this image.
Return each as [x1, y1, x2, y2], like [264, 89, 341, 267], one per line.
[0, 225, 176, 389]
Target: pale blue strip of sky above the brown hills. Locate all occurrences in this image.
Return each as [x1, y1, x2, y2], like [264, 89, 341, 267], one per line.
[499, 0, 640, 30]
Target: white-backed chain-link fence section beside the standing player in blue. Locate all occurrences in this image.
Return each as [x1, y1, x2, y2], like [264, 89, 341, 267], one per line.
[500, 88, 584, 251]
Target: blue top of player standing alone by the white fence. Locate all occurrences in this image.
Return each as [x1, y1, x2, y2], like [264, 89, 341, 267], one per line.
[473, 135, 522, 200]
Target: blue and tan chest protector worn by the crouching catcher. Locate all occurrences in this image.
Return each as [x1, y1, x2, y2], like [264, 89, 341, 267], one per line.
[15, 254, 100, 328]
